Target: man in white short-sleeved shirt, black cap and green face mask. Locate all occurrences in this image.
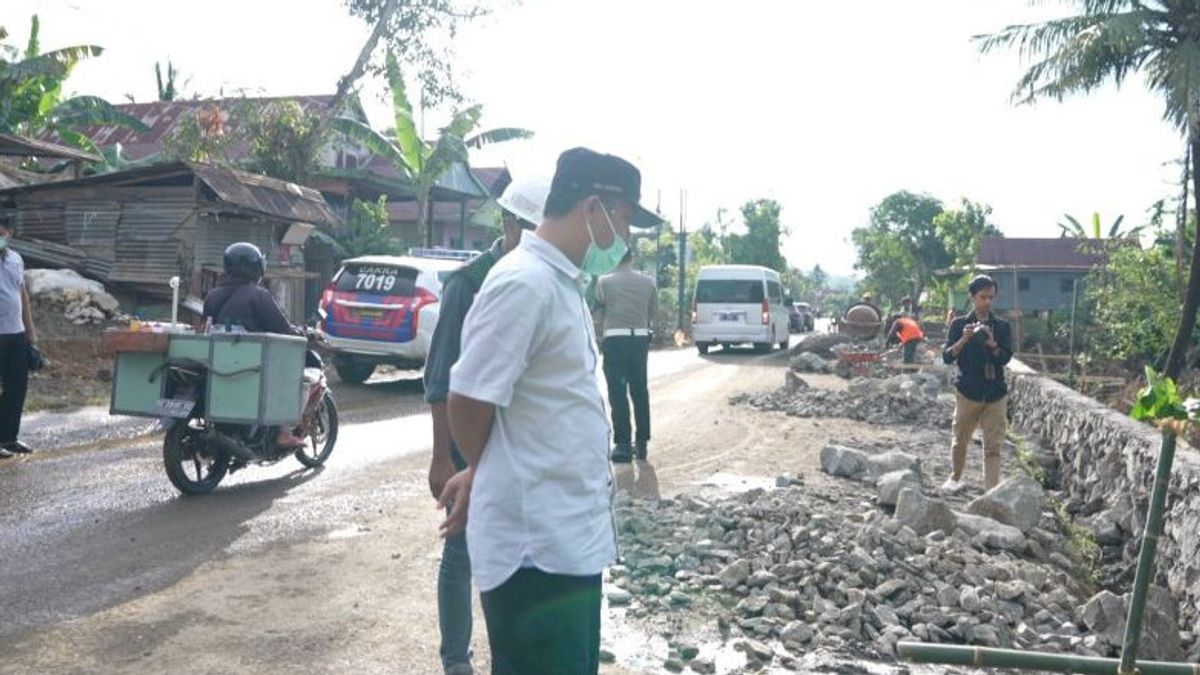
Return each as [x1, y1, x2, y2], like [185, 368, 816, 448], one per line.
[438, 148, 659, 675]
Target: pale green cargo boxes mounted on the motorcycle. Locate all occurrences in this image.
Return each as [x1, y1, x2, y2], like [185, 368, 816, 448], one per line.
[109, 333, 307, 425]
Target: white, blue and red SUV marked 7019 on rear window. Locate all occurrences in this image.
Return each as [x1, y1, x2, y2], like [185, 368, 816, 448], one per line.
[317, 249, 479, 383]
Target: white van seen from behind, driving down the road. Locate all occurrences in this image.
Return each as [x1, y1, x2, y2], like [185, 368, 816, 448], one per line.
[691, 265, 790, 354]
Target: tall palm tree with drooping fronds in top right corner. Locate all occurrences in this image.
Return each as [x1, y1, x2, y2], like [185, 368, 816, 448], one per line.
[976, 0, 1200, 380]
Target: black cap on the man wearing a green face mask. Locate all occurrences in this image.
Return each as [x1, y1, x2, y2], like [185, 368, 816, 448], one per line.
[550, 148, 662, 227]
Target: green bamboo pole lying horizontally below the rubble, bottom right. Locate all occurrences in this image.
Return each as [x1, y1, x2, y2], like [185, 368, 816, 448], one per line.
[896, 643, 1200, 675]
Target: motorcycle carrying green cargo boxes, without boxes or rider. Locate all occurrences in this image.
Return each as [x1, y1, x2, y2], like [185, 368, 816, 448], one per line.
[162, 331, 337, 495]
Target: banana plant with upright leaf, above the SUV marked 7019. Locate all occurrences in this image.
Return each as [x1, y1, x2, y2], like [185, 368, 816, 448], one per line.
[331, 52, 533, 246]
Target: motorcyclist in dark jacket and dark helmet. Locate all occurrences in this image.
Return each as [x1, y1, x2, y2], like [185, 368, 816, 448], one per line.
[204, 241, 305, 448]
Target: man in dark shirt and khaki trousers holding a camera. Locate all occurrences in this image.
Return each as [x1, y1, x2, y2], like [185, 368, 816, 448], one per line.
[942, 270, 1013, 494]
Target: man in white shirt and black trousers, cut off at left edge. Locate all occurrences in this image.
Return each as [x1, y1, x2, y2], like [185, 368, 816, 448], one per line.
[0, 221, 37, 459]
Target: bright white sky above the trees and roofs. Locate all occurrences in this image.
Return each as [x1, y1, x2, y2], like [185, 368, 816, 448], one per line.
[0, 0, 1184, 274]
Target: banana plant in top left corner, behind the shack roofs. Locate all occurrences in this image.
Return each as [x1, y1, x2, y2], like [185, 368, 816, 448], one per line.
[0, 14, 149, 154]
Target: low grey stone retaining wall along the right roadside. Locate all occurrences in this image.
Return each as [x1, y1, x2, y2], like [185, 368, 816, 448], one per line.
[1009, 369, 1200, 633]
